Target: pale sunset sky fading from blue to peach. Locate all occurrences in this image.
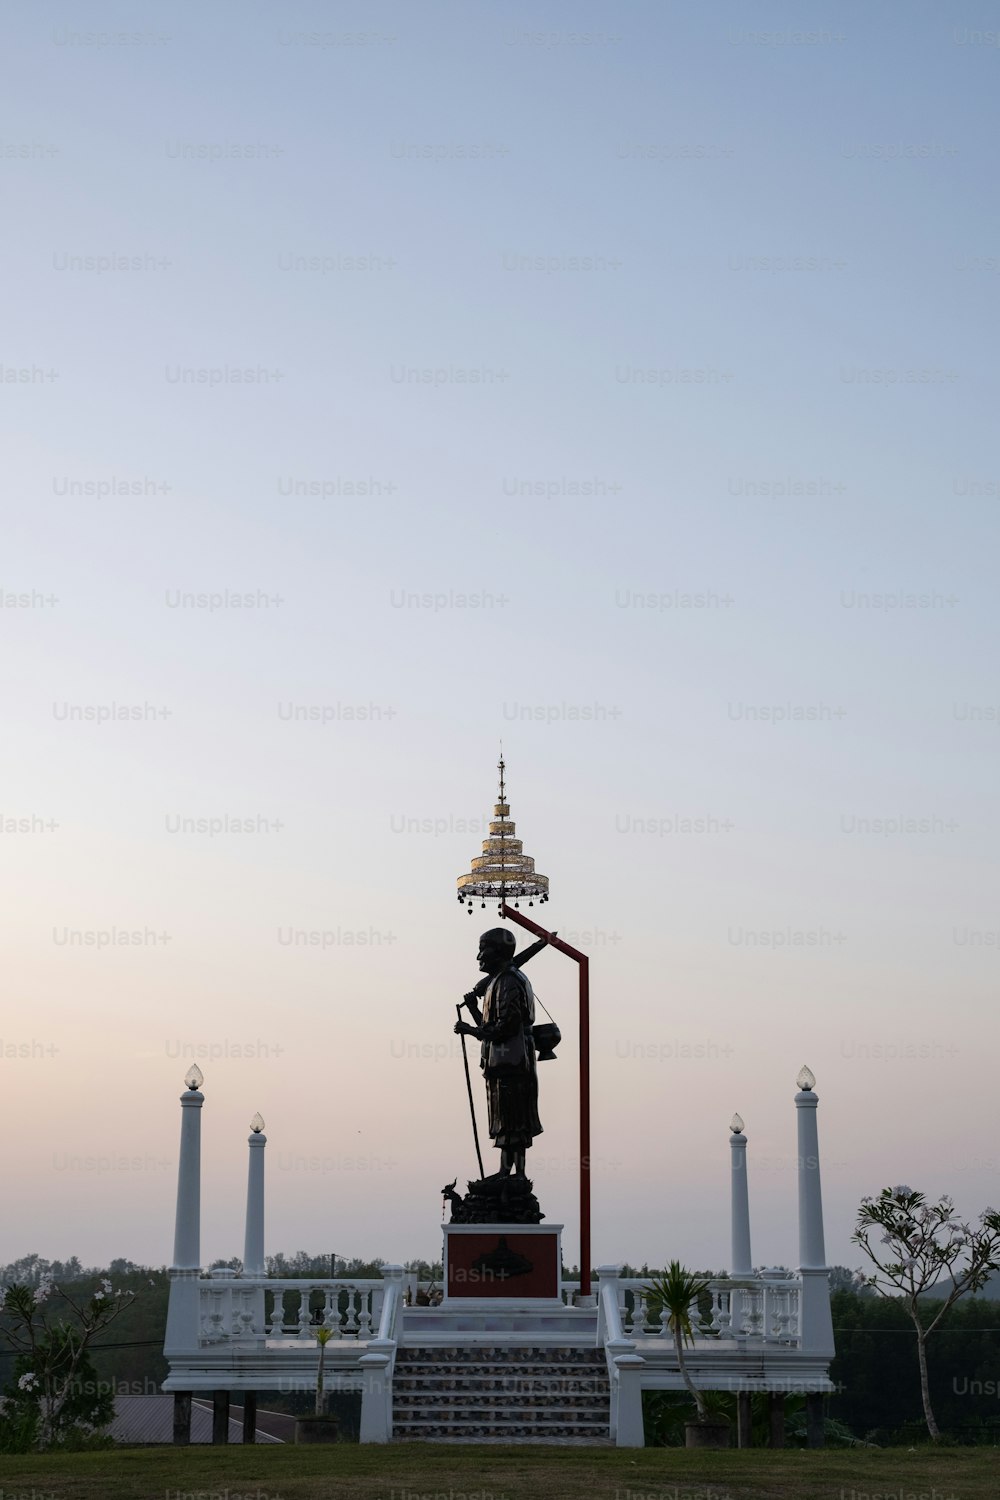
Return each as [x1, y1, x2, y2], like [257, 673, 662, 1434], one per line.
[0, 0, 1000, 1268]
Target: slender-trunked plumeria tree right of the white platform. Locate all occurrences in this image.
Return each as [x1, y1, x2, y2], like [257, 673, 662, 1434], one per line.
[852, 1184, 1000, 1443]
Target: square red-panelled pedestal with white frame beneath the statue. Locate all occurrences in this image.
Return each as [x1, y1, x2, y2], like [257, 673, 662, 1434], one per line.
[444, 1224, 562, 1305]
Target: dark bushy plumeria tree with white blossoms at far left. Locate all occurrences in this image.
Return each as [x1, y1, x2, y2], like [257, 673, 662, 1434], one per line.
[0, 1277, 135, 1448]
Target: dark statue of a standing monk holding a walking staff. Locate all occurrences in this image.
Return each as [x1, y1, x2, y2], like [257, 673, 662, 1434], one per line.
[454, 927, 543, 1178]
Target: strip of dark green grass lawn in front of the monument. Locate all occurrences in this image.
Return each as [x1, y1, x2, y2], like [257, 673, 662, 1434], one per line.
[0, 1443, 1000, 1500]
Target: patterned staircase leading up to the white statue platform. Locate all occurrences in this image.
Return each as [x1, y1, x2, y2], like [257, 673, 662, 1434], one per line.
[393, 1344, 612, 1446]
